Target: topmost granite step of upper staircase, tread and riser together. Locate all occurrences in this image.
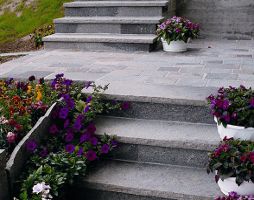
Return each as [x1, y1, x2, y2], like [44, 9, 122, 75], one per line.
[64, 0, 168, 17]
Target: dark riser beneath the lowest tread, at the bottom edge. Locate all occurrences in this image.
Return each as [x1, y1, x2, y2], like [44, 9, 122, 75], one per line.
[72, 187, 175, 200]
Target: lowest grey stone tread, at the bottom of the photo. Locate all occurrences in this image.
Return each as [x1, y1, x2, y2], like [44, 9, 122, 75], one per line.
[80, 161, 221, 200]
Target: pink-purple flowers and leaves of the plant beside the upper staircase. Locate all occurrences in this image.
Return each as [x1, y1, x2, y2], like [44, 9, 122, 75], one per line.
[157, 16, 200, 44]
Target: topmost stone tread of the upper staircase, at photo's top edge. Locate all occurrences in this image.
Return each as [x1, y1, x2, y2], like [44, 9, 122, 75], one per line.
[64, 0, 168, 7]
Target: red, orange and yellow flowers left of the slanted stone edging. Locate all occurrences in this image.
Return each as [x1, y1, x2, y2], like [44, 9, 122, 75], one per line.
[0, 76, 57, 151]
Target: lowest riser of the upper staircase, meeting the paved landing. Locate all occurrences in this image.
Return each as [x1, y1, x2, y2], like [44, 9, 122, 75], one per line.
[44, 41, 154, 52]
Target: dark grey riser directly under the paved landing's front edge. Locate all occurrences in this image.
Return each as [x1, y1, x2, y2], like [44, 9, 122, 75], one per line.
[105, 102, 214, 124]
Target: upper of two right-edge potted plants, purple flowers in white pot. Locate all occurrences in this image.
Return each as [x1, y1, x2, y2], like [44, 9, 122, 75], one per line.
[207, 86, 254, 140]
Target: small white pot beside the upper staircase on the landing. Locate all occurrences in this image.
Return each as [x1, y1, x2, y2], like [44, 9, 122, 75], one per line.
[161, 39, 187, 53]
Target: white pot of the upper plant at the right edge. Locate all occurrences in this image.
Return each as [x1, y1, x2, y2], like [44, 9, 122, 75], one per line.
[215, 118, 254, 141]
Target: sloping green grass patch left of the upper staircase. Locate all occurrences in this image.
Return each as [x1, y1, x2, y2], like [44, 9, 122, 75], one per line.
[0, 0, 71, 43]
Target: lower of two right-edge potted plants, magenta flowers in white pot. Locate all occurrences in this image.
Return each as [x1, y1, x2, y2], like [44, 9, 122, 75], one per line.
[207, 138, 254, 195]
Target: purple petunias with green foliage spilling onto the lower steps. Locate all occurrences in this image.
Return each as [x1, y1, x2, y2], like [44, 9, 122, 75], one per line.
[16, 74, 124, 200]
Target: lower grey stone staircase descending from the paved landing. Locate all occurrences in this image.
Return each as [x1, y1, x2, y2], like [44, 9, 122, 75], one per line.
[72, 87, 221, 200]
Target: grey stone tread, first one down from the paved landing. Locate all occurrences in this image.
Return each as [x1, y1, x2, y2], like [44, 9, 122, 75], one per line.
[96, 117, 220, 150]
